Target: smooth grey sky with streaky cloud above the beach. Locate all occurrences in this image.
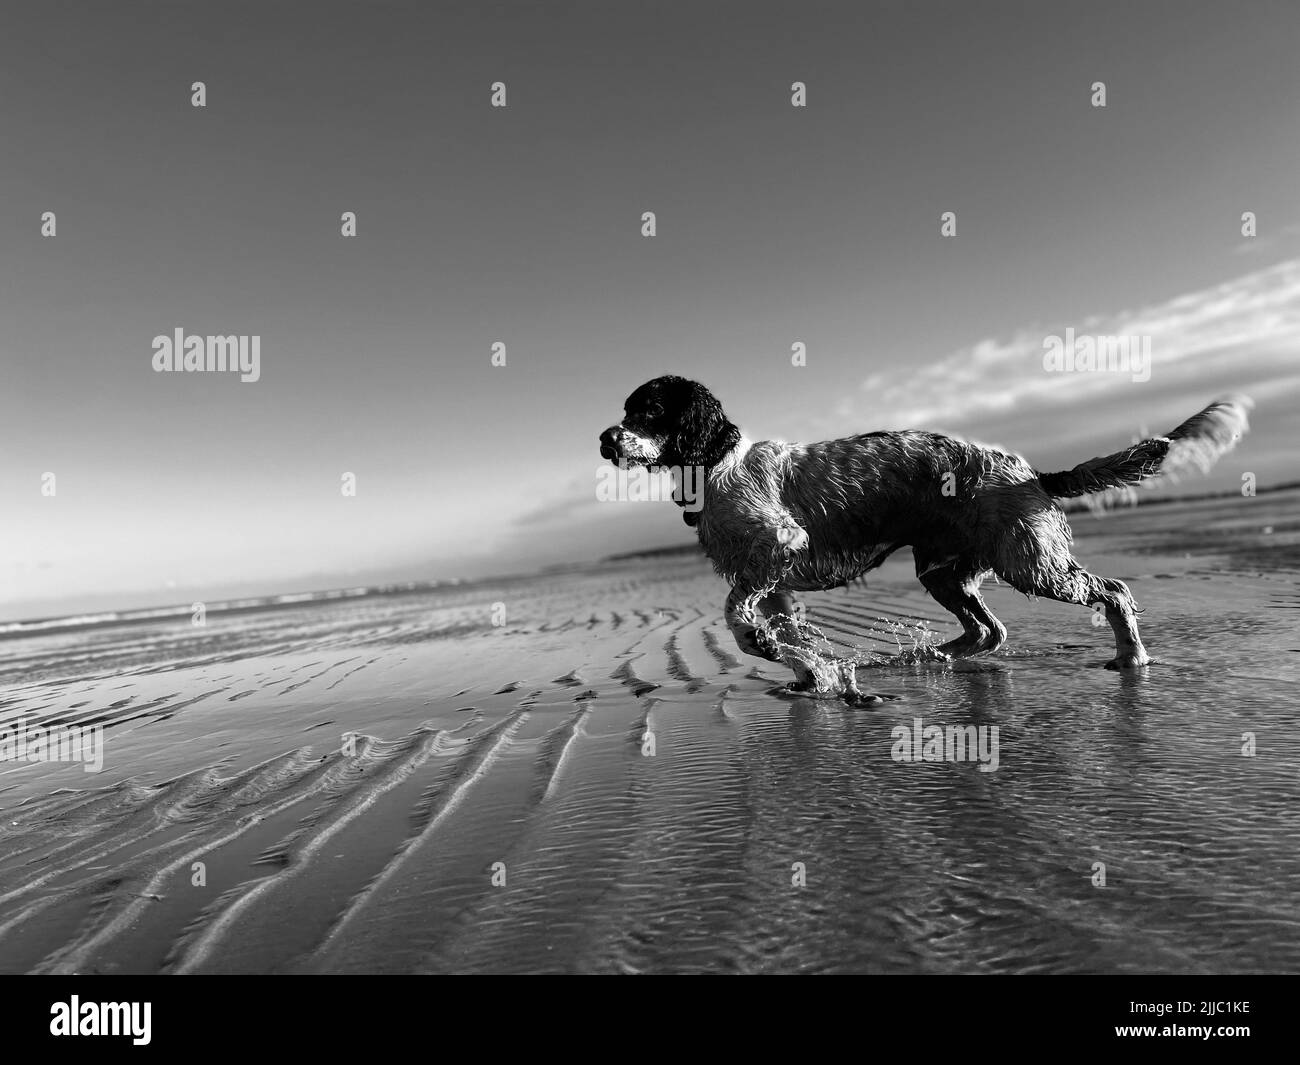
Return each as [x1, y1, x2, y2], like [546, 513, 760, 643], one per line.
[0, 0, 1300, 619]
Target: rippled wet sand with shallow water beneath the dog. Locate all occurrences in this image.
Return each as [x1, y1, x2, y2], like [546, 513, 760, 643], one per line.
[0, 493, 1300, 973]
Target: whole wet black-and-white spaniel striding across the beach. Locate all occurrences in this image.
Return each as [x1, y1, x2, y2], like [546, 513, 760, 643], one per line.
[601, 376, 1251, 687]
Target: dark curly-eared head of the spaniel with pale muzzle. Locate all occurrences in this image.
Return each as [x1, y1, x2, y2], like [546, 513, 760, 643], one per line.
[601, 375, 740, 467]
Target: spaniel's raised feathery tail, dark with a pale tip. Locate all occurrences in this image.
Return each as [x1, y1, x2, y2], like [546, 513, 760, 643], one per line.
[1039, 395, 1255, 499]
